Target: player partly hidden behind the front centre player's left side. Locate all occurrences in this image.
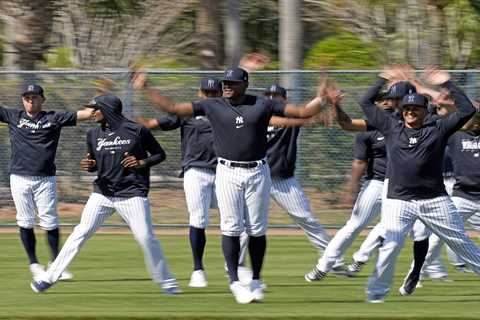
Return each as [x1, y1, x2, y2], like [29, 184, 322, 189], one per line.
[137, 77, 222, 288]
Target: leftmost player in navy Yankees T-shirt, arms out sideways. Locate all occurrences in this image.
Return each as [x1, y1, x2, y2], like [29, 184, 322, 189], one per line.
[0, 84, 92, 280]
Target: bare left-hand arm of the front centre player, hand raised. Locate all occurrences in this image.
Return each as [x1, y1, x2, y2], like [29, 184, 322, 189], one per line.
[133, 73, 193, 117]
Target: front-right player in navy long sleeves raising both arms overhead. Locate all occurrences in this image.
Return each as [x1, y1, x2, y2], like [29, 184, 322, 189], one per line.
[360, 70, 480, 303]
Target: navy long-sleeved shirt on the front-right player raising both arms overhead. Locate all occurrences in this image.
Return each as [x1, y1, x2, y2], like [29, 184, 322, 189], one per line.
[360, 80, 475, 201]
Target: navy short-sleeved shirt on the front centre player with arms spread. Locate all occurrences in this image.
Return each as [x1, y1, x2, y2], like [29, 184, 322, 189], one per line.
[193, 95, 285, 161]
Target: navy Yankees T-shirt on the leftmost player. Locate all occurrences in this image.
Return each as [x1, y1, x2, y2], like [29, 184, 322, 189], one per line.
[0, 107, 77, 176]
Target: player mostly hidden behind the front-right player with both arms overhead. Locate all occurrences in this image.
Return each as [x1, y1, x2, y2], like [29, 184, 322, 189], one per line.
[305, 81, 434, 282]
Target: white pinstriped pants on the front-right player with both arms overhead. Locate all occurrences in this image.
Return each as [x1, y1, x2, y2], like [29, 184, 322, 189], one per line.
[366, 196, 480, 296]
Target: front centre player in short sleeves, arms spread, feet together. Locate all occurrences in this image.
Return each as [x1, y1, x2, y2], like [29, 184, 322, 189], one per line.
[134, 68, 322, 303]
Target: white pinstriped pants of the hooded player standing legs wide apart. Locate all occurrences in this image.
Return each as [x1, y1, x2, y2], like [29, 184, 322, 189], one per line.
[45, 193, 175, 284]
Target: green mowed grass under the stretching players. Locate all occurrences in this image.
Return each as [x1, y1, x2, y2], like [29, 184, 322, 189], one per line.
[0, 231, 480, 320]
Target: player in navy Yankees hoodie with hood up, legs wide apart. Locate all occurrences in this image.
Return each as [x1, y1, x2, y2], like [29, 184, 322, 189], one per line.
[31, 94, 180, 294]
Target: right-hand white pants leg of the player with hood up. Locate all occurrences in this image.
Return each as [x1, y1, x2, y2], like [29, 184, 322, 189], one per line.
[113, 197, 175, 284]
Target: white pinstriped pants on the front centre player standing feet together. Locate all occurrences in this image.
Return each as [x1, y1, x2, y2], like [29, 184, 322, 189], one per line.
[215, 158, 271, 237]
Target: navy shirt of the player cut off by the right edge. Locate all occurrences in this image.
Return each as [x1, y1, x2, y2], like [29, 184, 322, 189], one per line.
[447, 131, 480, 201]
